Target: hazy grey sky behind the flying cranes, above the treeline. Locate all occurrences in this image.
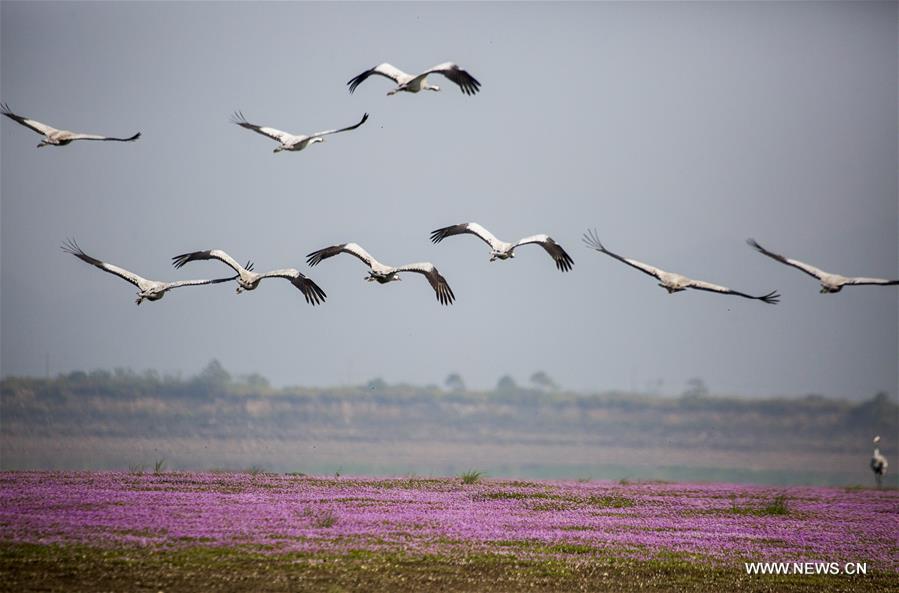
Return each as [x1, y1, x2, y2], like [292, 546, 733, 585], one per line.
[0, 2, 899, 397]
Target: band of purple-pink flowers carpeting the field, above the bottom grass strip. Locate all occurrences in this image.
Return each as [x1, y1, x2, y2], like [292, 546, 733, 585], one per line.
[0, 472, 899, 573]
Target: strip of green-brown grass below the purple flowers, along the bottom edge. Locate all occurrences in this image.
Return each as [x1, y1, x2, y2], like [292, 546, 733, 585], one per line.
[0, 541, 899, 593]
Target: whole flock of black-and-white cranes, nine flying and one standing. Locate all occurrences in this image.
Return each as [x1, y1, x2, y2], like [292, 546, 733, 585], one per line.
[0, 62, 899, 486]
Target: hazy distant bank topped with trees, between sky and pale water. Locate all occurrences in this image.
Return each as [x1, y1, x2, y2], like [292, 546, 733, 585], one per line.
[0, 361, 899, 451]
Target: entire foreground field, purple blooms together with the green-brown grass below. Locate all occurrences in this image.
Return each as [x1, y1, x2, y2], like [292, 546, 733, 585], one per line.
[0, 472, 899, 592]
